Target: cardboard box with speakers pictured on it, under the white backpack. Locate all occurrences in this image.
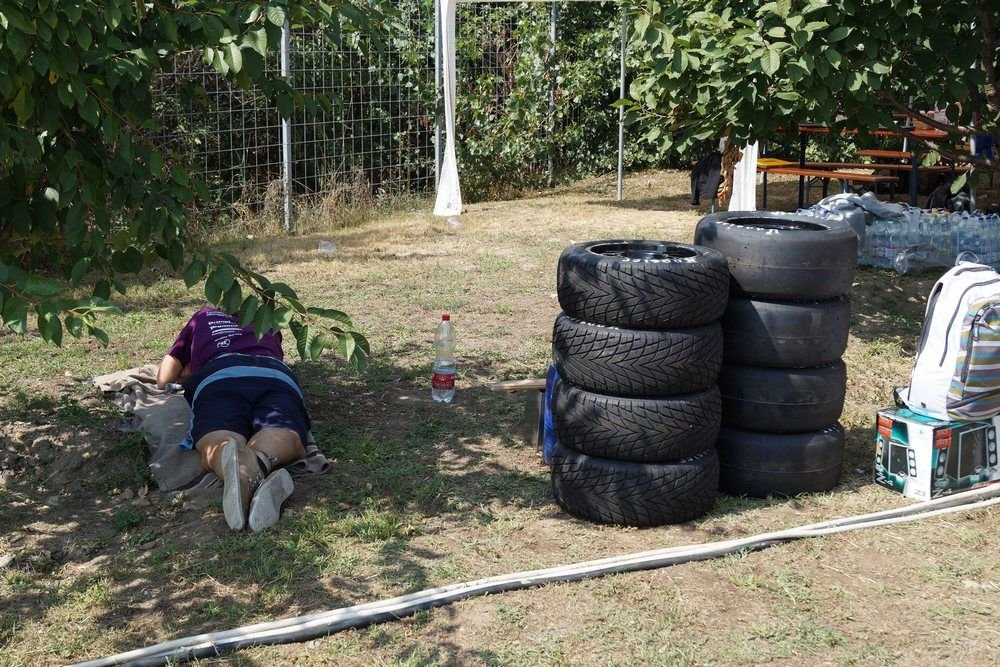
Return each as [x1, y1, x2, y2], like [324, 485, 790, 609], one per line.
[875, 408, 1000, 500]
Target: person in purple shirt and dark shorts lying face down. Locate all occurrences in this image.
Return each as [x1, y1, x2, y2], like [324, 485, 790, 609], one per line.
[156, 307, 310, 532]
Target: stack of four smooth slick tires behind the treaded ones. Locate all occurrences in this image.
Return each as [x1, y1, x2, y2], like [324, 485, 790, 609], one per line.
[695, 211, 857, 498]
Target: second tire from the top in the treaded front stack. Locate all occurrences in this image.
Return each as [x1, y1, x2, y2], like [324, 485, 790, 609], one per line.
[552, 314, 722, 396]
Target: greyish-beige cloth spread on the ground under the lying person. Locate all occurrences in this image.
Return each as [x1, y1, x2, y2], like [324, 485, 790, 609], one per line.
[93, 364, 330, 503]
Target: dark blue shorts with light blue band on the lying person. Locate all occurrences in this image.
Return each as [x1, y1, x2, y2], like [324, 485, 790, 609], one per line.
[181, 354, 310, 449]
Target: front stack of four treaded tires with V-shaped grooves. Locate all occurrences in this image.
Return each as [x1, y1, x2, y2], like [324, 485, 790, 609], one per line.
[552, 241, 729, 527]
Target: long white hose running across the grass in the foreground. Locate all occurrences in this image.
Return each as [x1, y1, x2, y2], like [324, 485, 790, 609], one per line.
[75, 484, 1000, 667]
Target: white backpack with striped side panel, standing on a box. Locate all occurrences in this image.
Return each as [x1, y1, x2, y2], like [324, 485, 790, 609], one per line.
[900, 262, 1000, 421]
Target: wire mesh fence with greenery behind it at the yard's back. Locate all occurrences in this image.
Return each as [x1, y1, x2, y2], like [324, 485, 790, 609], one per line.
[156, 0, 640, 228]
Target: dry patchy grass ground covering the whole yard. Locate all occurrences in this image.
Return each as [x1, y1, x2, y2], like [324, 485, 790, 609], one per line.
[0, 174, 1000, 666]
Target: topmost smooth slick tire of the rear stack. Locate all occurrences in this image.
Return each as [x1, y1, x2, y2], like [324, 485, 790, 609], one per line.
[694, 211, 858, 299]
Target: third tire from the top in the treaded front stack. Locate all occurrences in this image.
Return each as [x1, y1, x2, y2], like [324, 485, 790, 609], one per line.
[552, 380, 722, 463]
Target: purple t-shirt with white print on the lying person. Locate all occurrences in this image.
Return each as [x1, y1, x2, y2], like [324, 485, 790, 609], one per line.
[167, 308, 284, 373]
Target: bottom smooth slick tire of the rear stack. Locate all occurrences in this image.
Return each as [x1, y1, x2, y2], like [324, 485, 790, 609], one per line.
[716, 424, 844, 498]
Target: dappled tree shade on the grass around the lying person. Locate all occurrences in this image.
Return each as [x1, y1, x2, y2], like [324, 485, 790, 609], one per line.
[0, 351, 552, 660]
